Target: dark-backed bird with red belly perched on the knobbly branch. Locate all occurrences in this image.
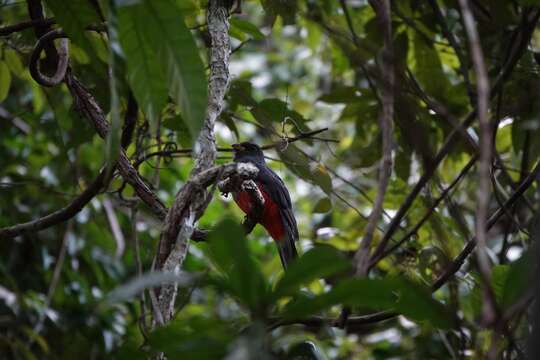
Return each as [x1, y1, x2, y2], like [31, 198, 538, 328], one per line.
[232, 142, 298, 269]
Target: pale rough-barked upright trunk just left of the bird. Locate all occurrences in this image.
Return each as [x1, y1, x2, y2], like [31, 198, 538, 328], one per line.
[156, 0, 231, 322]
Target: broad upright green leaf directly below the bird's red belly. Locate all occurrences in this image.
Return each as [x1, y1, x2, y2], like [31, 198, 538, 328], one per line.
[208, 218, 267, 312]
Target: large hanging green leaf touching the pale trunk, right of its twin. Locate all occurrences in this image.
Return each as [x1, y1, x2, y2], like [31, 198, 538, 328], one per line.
[125, 0, 207, 139]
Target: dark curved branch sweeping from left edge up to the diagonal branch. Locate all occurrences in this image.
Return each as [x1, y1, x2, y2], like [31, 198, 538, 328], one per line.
[0, 170, 106, 239]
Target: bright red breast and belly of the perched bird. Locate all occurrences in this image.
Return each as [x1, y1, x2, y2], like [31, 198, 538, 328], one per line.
[233, 182, 285, 241]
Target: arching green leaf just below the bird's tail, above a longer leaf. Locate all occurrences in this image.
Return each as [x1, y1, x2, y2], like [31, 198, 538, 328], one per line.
[274, 246, 352, 298]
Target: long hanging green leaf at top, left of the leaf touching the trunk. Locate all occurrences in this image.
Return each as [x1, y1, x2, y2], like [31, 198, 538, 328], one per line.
[118, 3, 167, 129]
